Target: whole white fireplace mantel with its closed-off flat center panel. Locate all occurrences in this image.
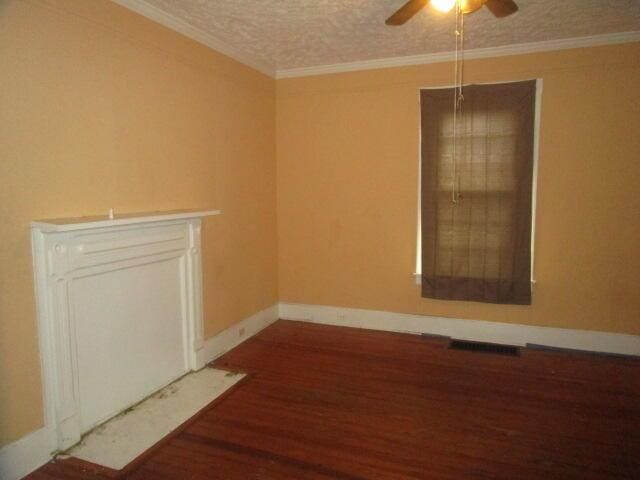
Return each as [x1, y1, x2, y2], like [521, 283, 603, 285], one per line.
[31, 210, 220, 450]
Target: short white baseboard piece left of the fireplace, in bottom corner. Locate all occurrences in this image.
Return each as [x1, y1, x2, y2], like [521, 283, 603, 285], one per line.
[0, 427, 53, 480]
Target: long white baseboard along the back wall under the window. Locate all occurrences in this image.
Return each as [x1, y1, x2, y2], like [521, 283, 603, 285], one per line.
[279, 303, 640, 356]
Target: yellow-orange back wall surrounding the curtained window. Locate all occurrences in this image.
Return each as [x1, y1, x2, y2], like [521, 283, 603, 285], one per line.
[276, 43, 640, 334]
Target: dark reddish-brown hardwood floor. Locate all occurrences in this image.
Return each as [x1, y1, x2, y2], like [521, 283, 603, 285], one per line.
[29, 321, 640, 480]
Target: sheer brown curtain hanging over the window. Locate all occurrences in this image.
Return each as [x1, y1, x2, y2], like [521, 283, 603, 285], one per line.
[420, 81, 536, 305]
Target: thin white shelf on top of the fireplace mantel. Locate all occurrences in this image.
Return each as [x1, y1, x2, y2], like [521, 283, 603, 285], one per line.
[31, 210, 221, 232]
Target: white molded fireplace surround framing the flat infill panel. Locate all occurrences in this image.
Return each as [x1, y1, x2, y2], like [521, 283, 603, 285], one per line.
[31, 216, 210, 451]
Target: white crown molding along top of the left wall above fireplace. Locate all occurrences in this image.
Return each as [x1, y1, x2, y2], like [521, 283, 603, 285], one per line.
[111, 0, 276, 77]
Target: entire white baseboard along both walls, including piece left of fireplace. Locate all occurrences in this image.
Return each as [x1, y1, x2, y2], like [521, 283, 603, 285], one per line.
[0, 303, 640, 480]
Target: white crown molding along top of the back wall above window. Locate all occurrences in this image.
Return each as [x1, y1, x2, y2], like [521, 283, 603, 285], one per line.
[276, 31, 640, 79]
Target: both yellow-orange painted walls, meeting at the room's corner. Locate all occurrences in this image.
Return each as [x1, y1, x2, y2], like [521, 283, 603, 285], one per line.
[5, 0, 640, 454]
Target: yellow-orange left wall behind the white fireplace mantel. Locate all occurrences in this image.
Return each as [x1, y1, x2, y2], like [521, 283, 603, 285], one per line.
[0, 0, 277, 445]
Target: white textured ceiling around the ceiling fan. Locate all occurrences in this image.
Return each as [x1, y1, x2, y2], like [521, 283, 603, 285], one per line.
[131, 0, 640, 71]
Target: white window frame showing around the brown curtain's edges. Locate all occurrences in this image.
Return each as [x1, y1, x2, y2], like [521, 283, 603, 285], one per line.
[413, 78, 543, 287]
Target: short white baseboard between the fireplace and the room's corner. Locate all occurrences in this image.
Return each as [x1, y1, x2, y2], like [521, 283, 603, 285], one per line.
[203, 303, 278, 363]
